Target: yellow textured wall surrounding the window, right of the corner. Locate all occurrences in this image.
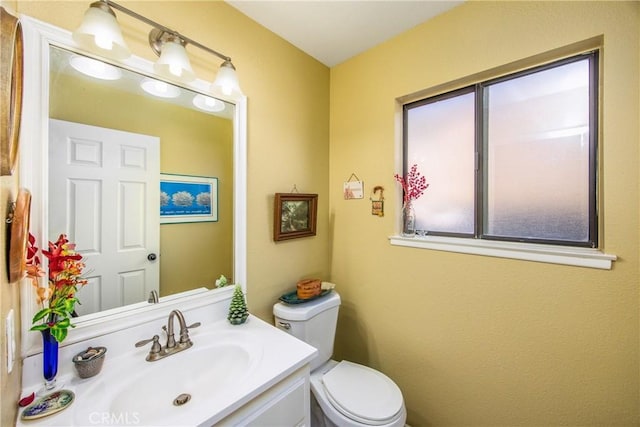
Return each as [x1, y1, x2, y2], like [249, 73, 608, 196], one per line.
[330, 2, 640, 426]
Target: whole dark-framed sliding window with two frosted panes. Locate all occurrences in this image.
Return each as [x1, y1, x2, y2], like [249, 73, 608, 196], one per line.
[403, 51, 598, 248]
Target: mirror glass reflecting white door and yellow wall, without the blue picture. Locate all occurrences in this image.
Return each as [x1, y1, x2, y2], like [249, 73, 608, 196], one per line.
[47, 46, 234, 315]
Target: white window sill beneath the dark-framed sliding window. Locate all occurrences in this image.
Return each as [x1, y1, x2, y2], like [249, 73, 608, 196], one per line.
[389, 236, 617, 270]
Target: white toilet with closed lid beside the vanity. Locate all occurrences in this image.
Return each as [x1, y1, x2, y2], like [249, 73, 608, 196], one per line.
[273, 291, 407, 427]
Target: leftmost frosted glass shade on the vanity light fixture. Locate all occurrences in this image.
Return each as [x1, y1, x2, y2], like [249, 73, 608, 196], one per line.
[72, 3, 131, 60]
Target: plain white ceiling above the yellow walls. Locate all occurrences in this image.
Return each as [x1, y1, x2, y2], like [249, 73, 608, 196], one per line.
[225, 0, 463, 67]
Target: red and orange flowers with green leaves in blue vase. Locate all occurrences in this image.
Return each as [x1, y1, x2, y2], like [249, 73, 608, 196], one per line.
[25, 233, 87, 342]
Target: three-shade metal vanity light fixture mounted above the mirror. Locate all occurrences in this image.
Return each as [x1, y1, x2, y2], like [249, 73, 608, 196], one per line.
[73, 0, 242, 95]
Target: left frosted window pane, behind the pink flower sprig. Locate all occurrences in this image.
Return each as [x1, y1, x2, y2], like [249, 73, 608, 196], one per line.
[405, 93, 475, 234]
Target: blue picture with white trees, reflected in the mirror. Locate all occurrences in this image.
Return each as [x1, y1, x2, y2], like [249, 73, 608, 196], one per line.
[160, 173, 218, 224]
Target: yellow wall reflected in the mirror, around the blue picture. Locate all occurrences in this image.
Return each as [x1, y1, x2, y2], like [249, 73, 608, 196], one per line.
[49, 74, 233, 296]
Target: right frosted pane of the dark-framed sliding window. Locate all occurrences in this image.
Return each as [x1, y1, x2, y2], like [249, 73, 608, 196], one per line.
[485, 60, 590, 242]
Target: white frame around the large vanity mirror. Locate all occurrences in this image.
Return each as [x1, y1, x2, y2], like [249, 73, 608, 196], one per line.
[19, 15, 247, 357]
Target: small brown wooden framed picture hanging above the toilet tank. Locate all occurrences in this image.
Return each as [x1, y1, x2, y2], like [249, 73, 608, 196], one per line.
[273, 193, 318, 242]
